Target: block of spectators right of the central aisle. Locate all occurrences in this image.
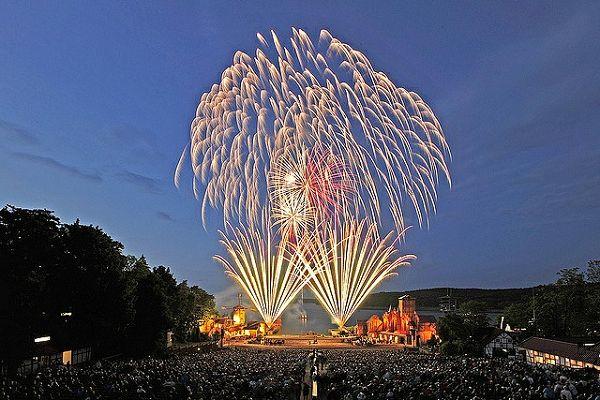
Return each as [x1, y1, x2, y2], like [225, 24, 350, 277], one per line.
[319, 348, 600, 400]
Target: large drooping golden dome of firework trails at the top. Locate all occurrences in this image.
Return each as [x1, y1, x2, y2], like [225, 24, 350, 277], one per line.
[175, 29, 450, 232]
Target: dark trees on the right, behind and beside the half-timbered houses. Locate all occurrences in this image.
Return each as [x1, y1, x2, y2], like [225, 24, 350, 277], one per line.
[438, 260, 600, 354]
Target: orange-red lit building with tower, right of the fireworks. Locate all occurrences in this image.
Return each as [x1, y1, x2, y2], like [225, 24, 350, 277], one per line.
[356, 295, 437, 346]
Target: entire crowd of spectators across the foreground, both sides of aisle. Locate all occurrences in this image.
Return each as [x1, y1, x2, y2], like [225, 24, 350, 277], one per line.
[0, 348, 600, 400]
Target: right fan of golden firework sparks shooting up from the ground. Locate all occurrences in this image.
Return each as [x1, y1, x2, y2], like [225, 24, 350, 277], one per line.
[304, 220, 416, 328]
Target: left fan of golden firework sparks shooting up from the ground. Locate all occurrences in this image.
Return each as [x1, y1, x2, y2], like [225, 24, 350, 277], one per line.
[214, 222, 315, 328]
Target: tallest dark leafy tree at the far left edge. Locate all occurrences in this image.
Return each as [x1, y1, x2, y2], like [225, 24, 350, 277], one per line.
[0, 206, 64, 372]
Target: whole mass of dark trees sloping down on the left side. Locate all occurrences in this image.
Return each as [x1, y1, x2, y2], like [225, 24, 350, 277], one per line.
[0, 206, 216, 376]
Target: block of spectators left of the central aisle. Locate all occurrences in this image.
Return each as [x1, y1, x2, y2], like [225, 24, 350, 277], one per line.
[0, 348, 308, 400]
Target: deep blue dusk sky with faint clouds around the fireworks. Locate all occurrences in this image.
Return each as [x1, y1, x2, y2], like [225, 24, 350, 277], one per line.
[0, 1, 600, 292]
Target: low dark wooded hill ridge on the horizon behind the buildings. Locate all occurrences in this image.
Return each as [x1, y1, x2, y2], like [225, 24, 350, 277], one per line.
[304, 287, 534, 310]
